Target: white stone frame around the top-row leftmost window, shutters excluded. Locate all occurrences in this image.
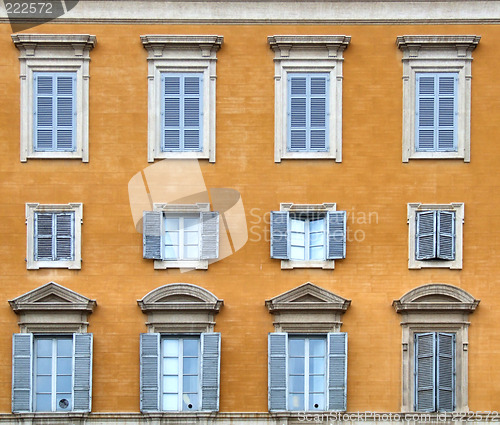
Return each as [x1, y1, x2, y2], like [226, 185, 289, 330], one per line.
[12, 34, 96, 162]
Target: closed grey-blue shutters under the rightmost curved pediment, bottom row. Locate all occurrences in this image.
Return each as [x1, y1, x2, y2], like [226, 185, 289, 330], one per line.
[415, 332, 455, 412]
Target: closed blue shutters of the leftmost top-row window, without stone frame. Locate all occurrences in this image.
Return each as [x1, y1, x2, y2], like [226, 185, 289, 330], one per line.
[33, 72, 76, 152]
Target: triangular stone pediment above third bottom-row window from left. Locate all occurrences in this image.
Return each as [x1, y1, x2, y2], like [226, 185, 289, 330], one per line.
[266, 282, 351, 333]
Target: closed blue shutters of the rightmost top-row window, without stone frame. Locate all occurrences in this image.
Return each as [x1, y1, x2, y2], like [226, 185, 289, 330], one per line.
[415, 73, 458, 152]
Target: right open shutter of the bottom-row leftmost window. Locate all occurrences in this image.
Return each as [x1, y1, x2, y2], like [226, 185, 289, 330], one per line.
[73, 333, 93, 412]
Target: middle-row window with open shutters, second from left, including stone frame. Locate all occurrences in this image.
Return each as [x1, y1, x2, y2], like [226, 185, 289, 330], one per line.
[143, 203, 219, 269]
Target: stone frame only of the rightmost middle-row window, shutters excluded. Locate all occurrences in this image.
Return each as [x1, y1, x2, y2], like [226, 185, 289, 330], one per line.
[408, 202, 464, 269]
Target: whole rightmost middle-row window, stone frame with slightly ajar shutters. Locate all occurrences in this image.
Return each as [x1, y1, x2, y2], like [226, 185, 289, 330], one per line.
[408, 203, 464, 269]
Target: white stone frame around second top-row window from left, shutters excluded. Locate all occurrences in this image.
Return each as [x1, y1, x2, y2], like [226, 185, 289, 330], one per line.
[141, 35, 223, 162]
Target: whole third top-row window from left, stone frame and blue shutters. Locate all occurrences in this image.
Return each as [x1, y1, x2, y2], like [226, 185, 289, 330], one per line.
[268, 35, 351, 162]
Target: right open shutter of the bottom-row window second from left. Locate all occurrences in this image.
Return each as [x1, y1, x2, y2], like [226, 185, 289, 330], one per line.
[201, 332, 221, 412]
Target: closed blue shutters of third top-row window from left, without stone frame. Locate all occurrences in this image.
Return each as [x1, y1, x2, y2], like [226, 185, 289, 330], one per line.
[287, 73, 330, 152]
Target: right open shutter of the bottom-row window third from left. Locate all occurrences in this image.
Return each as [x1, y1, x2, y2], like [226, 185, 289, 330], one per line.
[327, 332, 347, 411]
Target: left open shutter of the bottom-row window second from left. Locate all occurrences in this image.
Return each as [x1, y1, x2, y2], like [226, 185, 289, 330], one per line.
[140, 333, 161, 412]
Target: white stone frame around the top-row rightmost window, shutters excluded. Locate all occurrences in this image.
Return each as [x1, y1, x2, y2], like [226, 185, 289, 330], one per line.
[396, 35, 481, 162]
